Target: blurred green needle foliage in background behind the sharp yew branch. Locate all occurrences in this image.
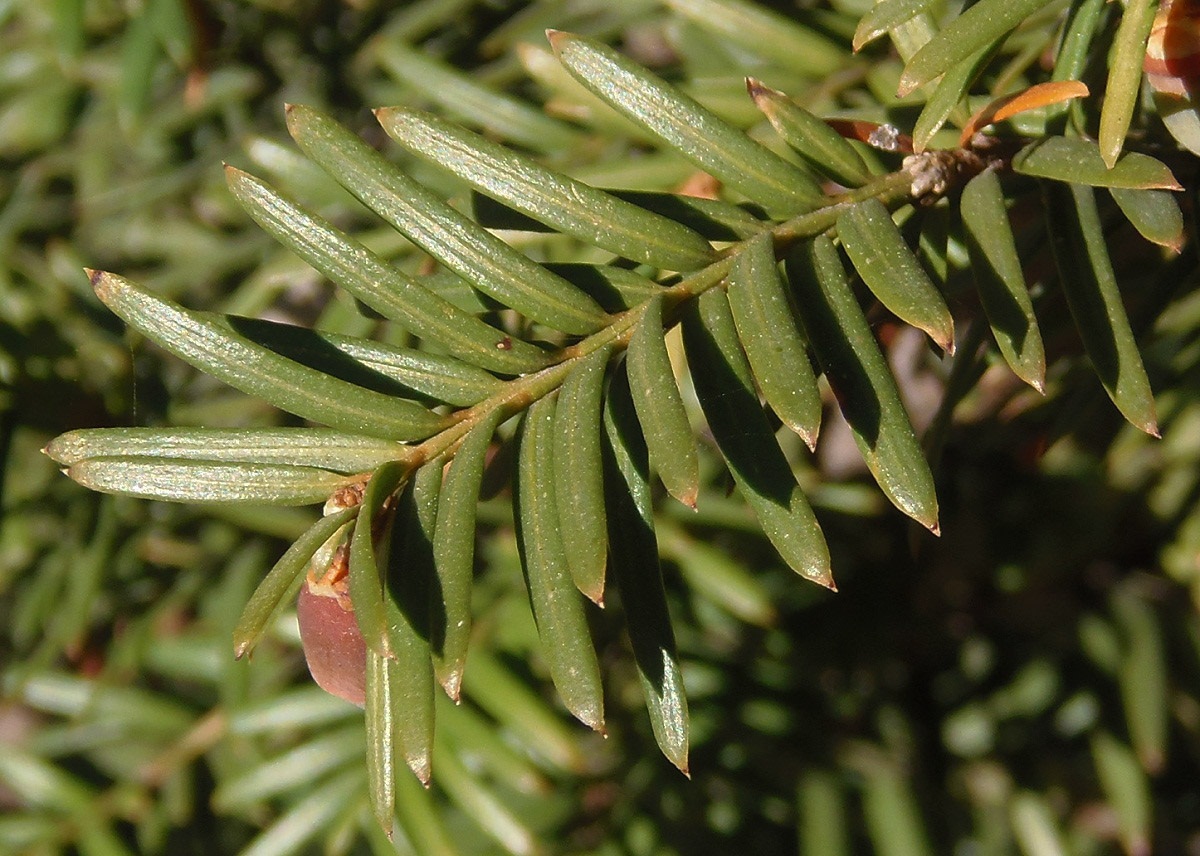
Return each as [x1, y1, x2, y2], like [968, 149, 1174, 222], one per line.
[7, 0, 1200, 856]
